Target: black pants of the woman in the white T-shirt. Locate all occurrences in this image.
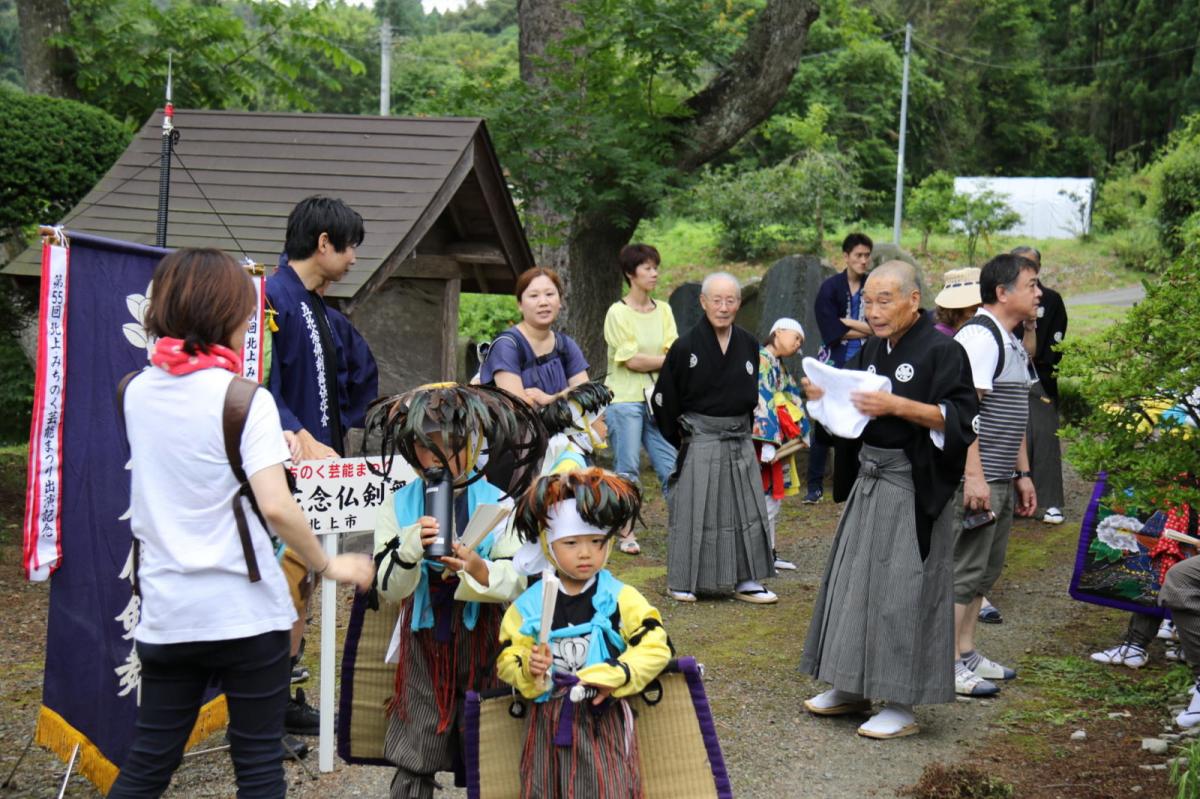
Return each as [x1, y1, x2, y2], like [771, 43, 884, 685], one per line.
[108, 630, 290, 799]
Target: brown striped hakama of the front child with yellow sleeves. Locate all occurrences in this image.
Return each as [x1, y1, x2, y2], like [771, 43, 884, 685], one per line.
[521, 686, 644, 799]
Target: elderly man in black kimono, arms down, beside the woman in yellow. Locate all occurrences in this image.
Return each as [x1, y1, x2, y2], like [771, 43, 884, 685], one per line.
[652, 272, 778, 605]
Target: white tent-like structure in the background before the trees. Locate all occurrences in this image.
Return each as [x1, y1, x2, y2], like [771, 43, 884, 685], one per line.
[954, 178, 1096, 239]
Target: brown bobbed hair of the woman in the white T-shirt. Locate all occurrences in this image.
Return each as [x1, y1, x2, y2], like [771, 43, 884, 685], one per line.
[145, 247, 257, 355]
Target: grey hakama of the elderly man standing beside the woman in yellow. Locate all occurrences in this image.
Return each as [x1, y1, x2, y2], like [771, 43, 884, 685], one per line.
[667, 413, 775, 594]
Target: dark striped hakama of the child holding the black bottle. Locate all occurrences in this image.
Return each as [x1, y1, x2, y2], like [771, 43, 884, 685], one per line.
[384, 599, 500, 799]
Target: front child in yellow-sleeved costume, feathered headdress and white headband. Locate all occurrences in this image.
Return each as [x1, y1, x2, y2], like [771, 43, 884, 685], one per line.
[497, 469, 671, 799]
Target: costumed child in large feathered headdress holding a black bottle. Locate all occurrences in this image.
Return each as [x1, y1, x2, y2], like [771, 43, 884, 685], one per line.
[366, 383, 545, 799]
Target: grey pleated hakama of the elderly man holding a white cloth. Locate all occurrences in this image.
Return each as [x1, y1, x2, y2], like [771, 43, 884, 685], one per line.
[800, 445, 954, 704]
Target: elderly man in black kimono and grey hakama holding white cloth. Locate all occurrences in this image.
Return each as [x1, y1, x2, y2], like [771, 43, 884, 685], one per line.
[800, 262, 978, 738]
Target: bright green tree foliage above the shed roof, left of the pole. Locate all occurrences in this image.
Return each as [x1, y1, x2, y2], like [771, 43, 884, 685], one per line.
[55, 0, 364, 125]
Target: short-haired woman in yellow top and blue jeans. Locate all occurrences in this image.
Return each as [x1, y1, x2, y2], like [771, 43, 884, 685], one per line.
[604, 244, 679, 554]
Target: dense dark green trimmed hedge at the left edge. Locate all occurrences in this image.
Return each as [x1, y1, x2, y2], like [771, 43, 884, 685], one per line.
[0, 88, 130, 238]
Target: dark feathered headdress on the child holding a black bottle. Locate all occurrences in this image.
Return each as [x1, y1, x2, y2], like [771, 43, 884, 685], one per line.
[364, 383, 547, 497]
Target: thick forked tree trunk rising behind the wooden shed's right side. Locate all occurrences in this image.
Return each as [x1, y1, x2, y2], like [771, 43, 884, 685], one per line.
[517, 0, 817, 359]
